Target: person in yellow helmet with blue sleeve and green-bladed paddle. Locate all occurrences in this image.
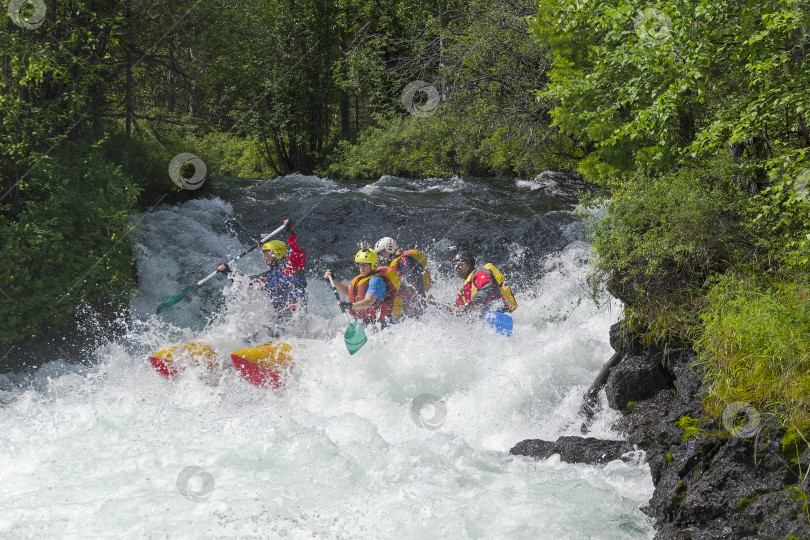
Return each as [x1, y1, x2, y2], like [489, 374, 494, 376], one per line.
[323, 248, 402, 326]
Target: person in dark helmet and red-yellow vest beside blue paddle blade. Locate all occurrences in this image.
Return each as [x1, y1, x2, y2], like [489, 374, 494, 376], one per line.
[451, 251, 517, 316]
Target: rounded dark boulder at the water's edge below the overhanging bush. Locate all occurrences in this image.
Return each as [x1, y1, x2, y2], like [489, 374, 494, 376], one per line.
[605, 355, 672, 411]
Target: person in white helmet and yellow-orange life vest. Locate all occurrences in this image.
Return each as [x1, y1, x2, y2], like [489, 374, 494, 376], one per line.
[374, 236, 431, 317]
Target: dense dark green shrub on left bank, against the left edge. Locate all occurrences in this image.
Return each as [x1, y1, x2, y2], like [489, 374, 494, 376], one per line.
[0, 143, 140, 345]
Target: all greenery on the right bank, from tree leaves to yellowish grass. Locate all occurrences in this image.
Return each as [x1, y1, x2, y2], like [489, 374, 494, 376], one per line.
[531, 0, 810, 448]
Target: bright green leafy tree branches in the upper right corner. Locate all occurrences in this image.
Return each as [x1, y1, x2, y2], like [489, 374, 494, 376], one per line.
[531, 0, 810, 181]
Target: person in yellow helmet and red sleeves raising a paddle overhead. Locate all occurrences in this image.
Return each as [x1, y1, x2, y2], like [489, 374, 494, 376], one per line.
[217, 219, 307, 317]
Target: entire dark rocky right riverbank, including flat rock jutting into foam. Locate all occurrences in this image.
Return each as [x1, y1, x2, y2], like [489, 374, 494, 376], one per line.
[511, 325, 810, 540]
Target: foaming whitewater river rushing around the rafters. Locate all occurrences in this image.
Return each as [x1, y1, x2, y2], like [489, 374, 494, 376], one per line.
[0, 174, 654, 540]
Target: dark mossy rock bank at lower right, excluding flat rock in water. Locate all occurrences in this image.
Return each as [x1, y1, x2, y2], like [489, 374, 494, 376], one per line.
[614, 322, 810, 540]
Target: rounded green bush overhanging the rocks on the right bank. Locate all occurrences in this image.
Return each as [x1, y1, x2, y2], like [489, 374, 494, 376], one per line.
[592, 156, 751, 342]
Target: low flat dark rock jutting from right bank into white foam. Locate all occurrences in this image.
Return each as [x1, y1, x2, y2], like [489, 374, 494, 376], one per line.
[509, 437, 635, 464]
